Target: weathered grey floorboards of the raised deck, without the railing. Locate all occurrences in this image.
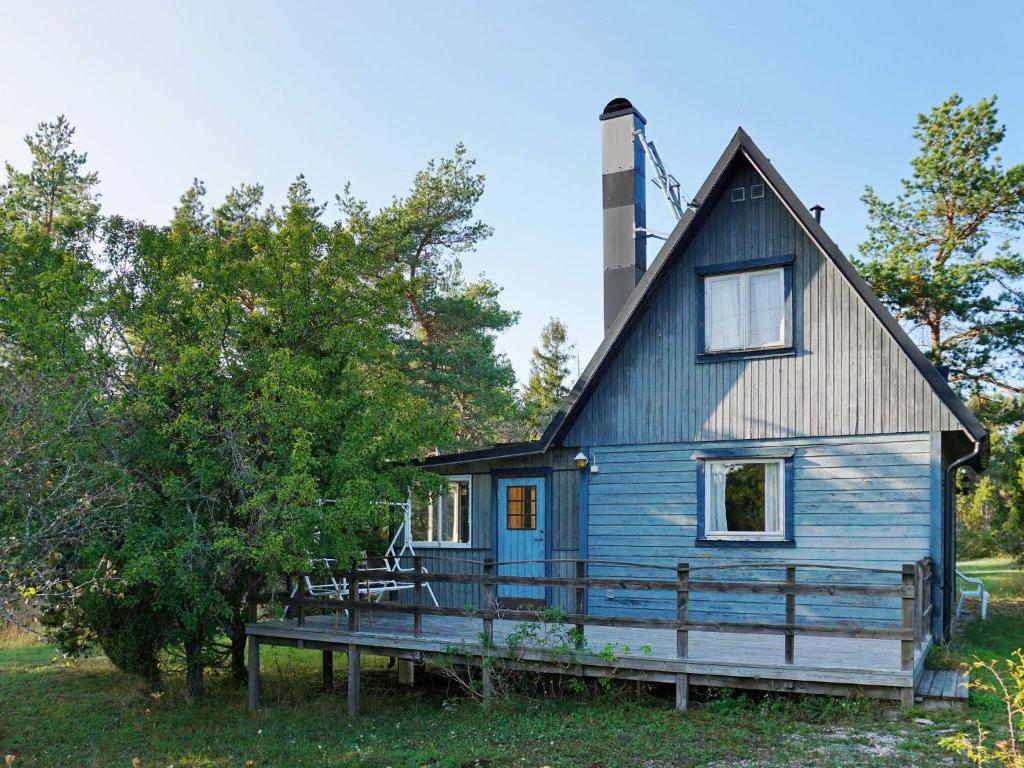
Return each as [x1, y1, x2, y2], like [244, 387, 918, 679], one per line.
[246, 613, 927, 699]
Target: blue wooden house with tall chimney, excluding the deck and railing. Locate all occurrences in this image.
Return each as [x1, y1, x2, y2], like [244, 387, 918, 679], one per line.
[414, 99, 987, 638]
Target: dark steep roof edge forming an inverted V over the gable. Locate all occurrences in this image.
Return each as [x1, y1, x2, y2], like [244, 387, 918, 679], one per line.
[539, 128, 988, 451]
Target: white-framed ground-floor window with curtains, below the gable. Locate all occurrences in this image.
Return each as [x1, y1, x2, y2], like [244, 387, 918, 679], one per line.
[703, 459, 785, 540]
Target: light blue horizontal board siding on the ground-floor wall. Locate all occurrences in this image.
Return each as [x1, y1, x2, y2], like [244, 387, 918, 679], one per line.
[588, 433, 932, 624]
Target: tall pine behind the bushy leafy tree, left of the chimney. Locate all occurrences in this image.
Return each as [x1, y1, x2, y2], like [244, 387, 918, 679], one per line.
[341, 144, 519, 447]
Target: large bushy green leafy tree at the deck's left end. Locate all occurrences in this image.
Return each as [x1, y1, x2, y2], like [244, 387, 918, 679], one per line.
[102, 178, 449, 696]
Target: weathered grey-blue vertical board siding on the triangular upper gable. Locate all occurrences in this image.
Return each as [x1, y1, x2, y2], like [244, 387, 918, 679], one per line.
[563, 161, 961, 445]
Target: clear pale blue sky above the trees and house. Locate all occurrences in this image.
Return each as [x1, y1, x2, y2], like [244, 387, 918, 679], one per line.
[0, 0, 1024, 385]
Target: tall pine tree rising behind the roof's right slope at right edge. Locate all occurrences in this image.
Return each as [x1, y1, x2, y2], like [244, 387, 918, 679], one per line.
[858, 94, 1024, 405]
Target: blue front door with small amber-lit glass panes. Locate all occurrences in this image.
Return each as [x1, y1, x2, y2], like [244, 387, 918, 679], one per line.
[497, 477, 545, 601]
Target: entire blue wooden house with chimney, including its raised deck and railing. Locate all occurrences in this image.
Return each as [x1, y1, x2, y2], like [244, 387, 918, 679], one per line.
[246, 99, 987, 715]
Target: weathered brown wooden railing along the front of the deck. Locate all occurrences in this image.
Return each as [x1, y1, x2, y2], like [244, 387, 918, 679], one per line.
[250, 555, 934, 708]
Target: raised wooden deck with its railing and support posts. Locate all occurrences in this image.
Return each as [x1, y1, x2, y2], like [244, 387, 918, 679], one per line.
[246, 556, 932, 716]
